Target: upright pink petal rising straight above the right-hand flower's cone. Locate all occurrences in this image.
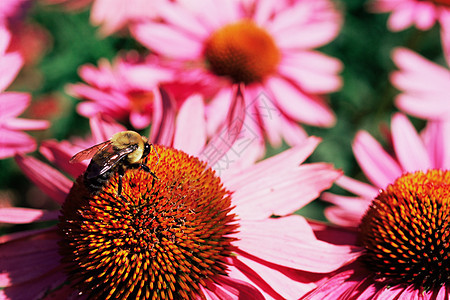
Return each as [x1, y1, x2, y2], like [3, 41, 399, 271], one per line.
[391, 113, 433, 172]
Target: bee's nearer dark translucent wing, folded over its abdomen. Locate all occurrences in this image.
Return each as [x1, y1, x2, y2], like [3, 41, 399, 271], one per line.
[86, 144, 136, 178]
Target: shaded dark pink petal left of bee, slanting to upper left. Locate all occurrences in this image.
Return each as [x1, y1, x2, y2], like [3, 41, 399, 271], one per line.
[15, 154, 73, 204]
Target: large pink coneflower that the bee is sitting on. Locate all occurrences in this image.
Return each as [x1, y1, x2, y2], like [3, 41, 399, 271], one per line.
[0, 112, 349, 299]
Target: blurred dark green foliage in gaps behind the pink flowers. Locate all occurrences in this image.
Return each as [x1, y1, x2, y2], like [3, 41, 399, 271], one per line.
[0, 0, 444, 223]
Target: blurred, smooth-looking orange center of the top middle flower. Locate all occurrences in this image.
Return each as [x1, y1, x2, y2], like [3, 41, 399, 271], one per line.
[204, 20, 280, 84]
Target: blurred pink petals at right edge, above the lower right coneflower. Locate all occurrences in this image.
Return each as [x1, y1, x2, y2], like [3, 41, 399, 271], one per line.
[391, 48, 450, 120]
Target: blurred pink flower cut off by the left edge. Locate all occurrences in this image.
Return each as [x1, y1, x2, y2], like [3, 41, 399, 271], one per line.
[0, 26, 49, 159]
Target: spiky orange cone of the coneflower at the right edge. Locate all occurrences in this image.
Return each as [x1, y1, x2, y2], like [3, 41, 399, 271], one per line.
[360, 170, 450, 291]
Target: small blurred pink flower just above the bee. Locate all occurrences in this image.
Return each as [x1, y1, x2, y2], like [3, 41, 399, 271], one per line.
[67, 53, 172, 129]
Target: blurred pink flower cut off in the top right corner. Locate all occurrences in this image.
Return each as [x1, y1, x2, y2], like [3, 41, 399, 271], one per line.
[370, 0, 450, 31]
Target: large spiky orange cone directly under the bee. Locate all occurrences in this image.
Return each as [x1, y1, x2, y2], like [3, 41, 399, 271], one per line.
[59, 146, 238, 299]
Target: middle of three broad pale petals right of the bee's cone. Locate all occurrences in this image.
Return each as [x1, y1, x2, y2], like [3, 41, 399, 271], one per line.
[233, 163, 341, 220]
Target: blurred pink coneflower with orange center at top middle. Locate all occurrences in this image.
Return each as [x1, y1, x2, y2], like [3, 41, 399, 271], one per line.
[131, 0, 342, 144]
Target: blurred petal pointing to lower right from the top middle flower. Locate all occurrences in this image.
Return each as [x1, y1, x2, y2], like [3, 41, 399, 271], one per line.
[267, 77, 335, 126]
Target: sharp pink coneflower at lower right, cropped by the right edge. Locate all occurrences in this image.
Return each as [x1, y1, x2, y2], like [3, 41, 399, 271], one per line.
[296, 114, 450, 300]
